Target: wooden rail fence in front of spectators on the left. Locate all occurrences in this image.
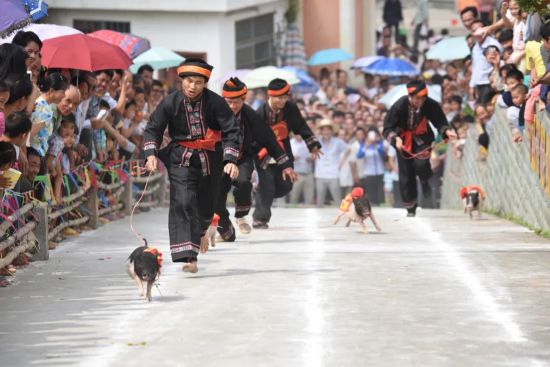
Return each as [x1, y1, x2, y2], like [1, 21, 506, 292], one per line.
[0, 161, 168, 269]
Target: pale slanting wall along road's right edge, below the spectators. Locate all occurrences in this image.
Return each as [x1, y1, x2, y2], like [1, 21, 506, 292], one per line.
[441, 109, 550, 233]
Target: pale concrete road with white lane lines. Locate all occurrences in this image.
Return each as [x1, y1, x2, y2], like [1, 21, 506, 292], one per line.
[0, 209, 550, 367]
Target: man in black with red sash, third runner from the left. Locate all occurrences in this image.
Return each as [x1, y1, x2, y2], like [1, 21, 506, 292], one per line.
[252, 79, 322, 229]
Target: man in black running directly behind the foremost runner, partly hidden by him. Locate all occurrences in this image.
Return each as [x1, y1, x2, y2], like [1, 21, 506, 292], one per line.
[216, 78, 297, 242]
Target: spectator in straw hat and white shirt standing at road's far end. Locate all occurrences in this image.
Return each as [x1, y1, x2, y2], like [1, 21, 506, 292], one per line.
[315, 119, 348, 207]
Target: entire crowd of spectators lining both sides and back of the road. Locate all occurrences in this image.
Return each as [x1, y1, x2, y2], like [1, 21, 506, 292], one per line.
[0, 0, 550, 239]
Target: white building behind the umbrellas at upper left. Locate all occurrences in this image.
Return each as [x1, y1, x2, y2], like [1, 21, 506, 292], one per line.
[47, 0, 288, 88]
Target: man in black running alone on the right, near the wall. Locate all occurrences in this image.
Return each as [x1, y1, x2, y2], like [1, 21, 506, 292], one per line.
[384, 80, 456, 217]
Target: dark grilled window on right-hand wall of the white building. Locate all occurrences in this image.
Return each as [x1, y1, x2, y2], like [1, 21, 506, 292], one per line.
[235, 13, 276, 69]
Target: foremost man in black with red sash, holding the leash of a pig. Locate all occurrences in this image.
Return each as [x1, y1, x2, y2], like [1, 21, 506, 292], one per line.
[143, 58, 240, 273]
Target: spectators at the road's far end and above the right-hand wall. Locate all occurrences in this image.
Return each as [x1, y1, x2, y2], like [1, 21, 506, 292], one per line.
[274, 0, 550, 208]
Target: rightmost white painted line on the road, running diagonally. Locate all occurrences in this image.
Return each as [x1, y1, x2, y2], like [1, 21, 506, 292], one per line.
[413, 218, 527, 343]
